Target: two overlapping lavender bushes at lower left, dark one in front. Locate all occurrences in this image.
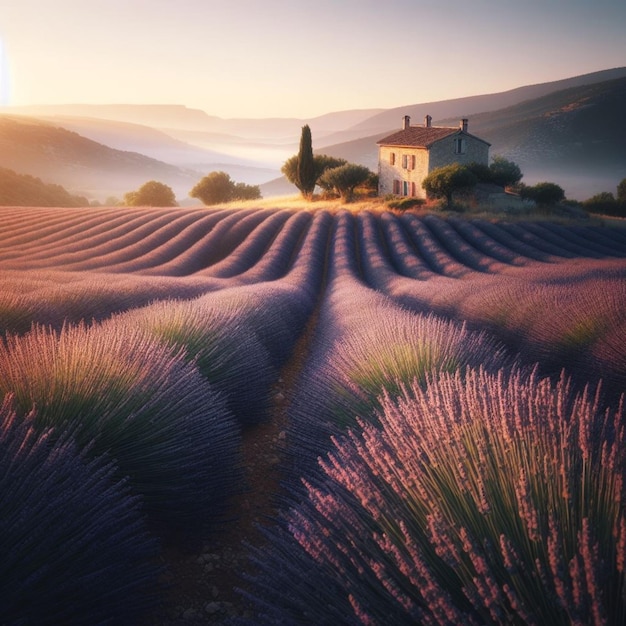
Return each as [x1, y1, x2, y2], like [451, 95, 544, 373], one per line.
[0, 322, 242, 624]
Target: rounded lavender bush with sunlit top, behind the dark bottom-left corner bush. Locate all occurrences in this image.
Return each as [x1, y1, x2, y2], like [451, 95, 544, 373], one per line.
[0, 325, 239, 531]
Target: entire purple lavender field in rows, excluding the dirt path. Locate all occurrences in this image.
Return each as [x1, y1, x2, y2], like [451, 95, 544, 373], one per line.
[0, 207, 626, 624]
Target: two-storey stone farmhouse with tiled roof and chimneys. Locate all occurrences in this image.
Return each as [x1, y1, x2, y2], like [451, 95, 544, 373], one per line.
[376, 115, 491, 198]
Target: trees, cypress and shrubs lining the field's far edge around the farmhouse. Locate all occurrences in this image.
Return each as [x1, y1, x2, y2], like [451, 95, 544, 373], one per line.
[0, 124, 626, 217]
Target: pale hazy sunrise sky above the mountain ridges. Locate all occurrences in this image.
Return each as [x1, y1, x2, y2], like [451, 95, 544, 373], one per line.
[0, 0, 626, 119]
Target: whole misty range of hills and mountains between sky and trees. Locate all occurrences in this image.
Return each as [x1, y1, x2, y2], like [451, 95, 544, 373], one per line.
[0, 67, 626, 199]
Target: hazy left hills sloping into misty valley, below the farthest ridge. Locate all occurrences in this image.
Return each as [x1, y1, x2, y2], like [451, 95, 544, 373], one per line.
[0, 115, 275, 201]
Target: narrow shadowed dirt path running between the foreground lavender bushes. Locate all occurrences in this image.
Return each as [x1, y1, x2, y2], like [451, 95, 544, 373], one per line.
[145, 315, 317, 626]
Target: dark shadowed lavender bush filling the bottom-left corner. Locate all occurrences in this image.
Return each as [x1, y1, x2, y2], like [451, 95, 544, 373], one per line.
[0, 396, 160, 625]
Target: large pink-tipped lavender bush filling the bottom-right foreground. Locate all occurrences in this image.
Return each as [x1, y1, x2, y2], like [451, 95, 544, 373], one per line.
[246, 370, 626, 625]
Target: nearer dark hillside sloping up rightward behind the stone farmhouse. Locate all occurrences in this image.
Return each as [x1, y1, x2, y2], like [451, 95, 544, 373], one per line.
[317, 77, 626, 199]
